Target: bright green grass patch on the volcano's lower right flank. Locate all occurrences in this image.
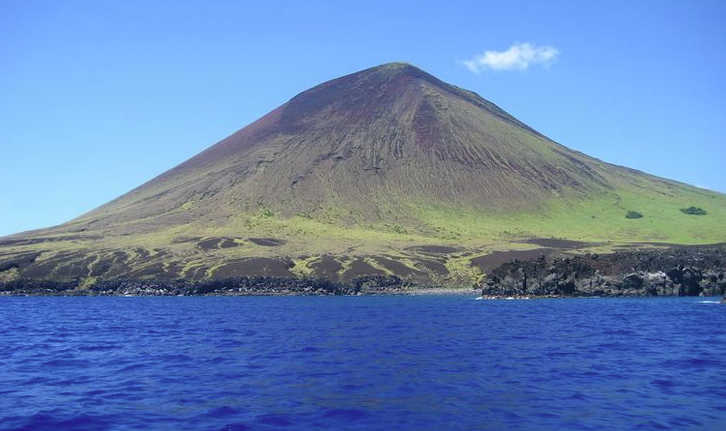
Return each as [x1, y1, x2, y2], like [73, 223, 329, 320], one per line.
[412, 183, 726, 248]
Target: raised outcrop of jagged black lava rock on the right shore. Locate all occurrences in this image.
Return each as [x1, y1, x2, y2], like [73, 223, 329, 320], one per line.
[482, 245, 726, 298]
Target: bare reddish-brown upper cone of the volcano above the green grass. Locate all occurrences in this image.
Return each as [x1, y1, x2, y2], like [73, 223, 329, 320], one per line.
[61, 63, 631, 228]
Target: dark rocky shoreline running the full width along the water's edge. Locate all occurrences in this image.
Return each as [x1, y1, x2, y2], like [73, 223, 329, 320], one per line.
[5, 245, 726, 299]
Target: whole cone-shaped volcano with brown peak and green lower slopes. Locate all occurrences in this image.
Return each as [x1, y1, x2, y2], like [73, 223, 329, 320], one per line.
[0, 63, 726, 286]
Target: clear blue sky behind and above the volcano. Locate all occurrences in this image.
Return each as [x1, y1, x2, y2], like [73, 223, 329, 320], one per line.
[0, 0, 726, 235]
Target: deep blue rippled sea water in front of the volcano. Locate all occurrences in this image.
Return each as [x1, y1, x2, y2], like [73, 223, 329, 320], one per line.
[0, 296, 726, 430]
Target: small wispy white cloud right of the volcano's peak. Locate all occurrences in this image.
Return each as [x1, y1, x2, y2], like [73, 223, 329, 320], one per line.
[461, 43, 560, 73]
